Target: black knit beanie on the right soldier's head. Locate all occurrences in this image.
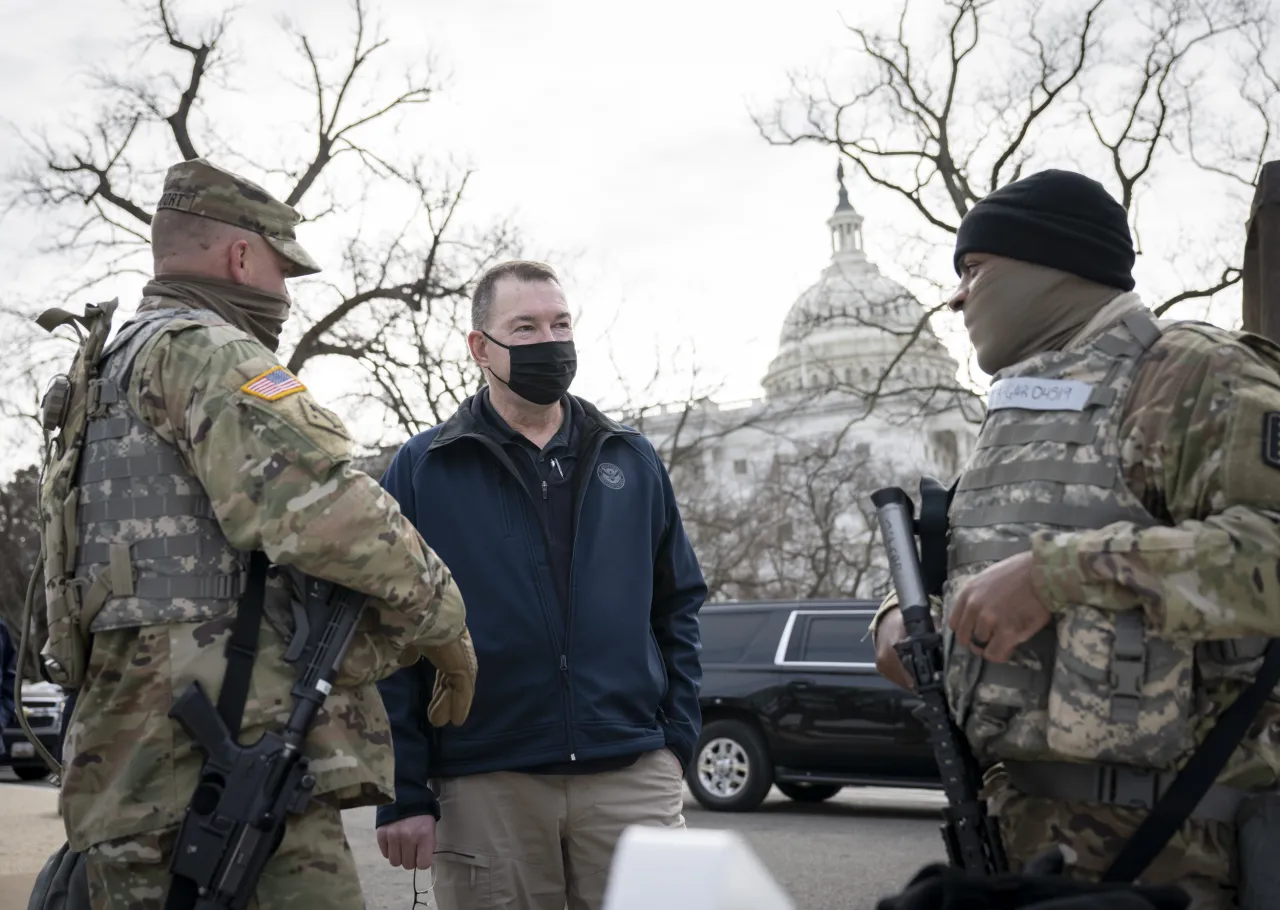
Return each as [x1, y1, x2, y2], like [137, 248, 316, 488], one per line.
[954, 170, 1135, 291]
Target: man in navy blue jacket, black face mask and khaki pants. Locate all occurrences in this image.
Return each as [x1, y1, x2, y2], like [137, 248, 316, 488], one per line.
[378, 261, 707, 910]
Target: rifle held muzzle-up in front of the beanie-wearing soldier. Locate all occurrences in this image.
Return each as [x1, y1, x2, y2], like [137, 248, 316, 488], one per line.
[872, 477, 1009, 875]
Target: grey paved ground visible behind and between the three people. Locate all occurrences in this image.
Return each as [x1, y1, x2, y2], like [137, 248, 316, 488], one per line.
[0, 769, 942, 910]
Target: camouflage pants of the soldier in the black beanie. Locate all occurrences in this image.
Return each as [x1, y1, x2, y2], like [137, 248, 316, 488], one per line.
[988, 785, 1238, 910]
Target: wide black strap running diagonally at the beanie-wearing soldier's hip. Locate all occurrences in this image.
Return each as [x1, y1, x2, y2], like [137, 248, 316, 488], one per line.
[1102, 639, 1280, 882]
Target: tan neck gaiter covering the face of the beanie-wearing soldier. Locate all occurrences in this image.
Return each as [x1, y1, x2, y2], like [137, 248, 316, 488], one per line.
[963, 259, 1124, 374]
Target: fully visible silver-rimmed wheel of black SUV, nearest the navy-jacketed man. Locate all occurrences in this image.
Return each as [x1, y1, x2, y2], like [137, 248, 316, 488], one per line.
[687, 721, 773, 811]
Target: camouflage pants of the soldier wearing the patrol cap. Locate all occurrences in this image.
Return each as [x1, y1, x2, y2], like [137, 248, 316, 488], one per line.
[84, 801, 365, 910]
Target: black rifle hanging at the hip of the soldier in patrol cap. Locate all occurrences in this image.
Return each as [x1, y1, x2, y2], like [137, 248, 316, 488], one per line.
[169, 579, 365, 910]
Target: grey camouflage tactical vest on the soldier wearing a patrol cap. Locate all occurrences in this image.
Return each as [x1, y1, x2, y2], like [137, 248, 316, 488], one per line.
[42, 302, 248, 687]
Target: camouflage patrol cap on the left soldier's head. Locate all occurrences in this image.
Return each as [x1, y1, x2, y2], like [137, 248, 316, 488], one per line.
[156, 157, 320, 278]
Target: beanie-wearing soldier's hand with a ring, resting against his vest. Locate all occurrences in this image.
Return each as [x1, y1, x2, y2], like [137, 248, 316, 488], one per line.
[952, 552, 1053, 666]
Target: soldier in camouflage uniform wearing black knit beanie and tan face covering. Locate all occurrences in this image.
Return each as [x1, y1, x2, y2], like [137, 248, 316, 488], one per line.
[873, 172, 1280, 910]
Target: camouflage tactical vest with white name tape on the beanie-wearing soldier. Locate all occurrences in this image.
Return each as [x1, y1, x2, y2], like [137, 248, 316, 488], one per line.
[943, 308, 1267, 769]
